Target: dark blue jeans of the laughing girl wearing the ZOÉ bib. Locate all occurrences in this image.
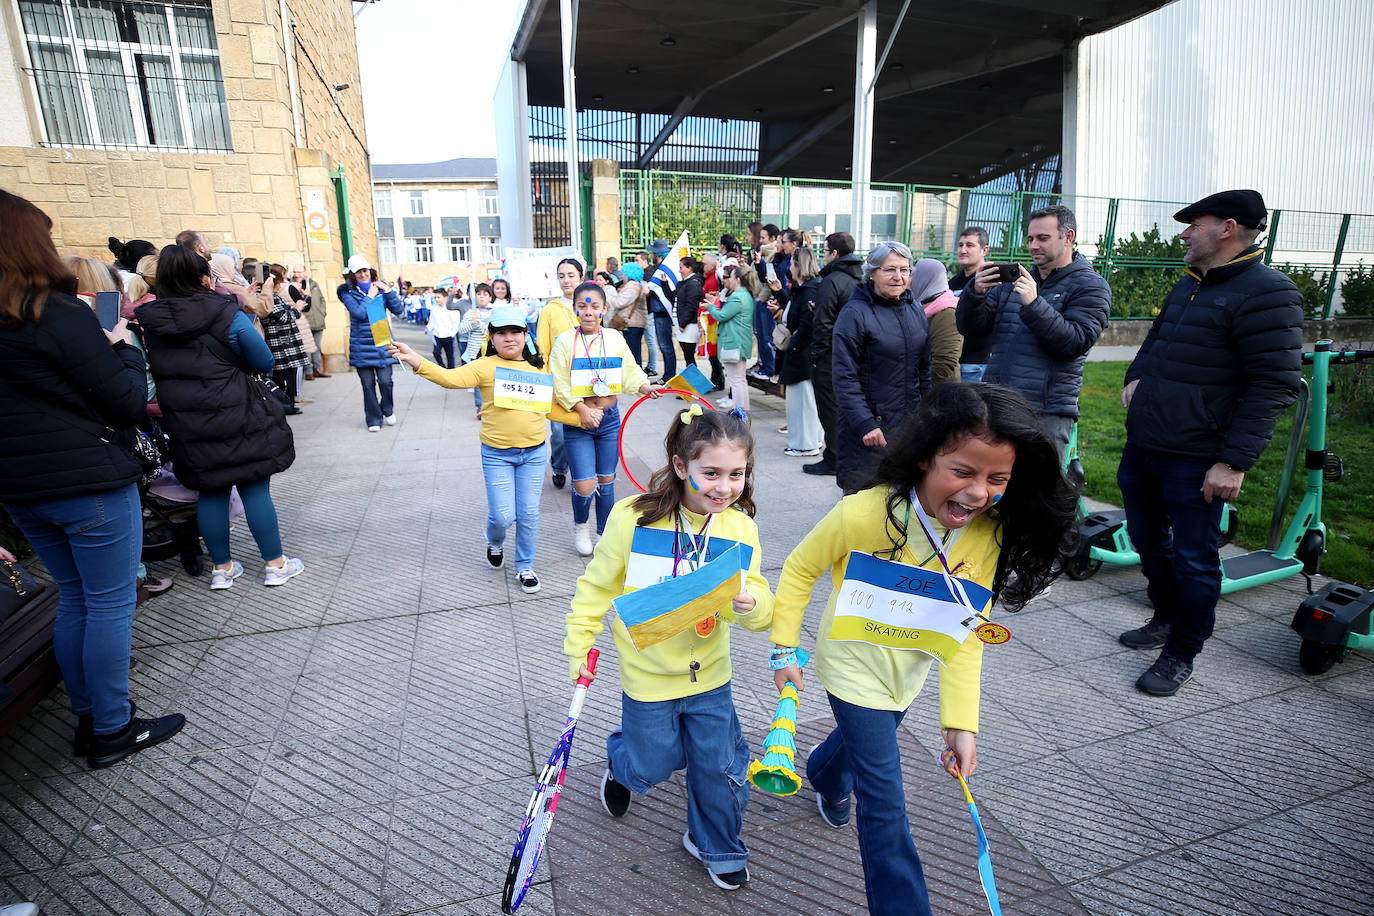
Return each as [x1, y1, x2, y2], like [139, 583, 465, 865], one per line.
[807, 694, 930, 916]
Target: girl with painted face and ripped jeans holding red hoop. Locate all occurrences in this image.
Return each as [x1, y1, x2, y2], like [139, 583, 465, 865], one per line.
[552, 283, 664, 556]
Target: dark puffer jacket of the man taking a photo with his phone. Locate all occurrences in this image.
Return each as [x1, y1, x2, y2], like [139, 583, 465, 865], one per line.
[955, 253, 1112, 417]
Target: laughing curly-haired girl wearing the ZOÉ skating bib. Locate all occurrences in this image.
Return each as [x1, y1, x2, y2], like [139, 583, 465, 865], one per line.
[771, 383, 1076, 916]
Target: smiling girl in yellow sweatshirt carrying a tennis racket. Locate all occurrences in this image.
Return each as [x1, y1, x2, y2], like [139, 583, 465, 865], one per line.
[563, 405, 774, 890]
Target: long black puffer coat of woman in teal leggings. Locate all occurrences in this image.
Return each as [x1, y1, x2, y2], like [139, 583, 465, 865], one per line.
[135, 291, 295, 490]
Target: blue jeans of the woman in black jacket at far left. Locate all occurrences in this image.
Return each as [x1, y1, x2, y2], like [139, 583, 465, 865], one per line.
[5, 483, 143, 735]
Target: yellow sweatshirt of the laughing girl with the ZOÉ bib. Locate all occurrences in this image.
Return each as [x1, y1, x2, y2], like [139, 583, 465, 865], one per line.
[771, 488, 1000, 732]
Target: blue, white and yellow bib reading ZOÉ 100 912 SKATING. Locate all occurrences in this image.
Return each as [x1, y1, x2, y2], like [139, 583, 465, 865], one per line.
[830, 551, 992, 665]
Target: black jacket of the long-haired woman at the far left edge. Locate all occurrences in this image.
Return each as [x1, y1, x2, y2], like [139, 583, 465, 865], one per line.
[0, 293, 148, 503]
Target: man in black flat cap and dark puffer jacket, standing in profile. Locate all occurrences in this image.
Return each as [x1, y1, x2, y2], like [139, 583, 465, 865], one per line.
[1117, 191, 1303, 696]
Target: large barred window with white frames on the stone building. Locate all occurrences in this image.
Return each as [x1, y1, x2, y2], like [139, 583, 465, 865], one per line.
[19, 0, 234, 150]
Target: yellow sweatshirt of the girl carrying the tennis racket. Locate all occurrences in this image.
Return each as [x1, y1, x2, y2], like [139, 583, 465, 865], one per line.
[563, 497, 774, 703]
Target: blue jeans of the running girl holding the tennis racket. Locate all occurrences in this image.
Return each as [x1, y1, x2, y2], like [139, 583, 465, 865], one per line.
[606, 684, 750, 875]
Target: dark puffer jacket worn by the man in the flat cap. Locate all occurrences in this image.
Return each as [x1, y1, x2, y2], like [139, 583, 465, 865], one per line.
[1125, 246, 1303, 471]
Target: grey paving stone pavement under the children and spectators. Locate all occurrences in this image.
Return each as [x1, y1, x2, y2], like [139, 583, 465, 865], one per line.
[0, 328, 1374, 916]
